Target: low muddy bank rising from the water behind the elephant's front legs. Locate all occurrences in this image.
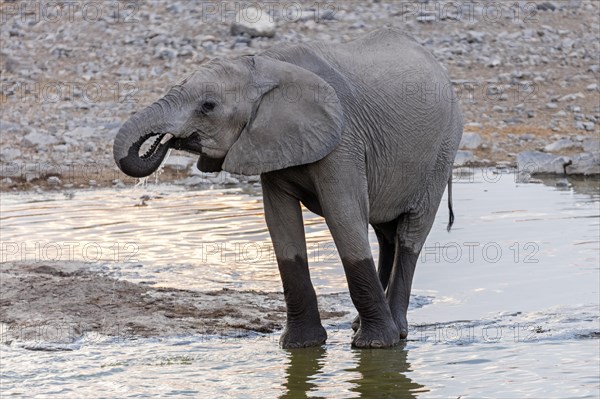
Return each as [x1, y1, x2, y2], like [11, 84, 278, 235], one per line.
[0, 263, 352, 344]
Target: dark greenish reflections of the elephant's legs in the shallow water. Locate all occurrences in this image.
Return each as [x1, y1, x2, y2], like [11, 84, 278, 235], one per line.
[280, 343, 428, 399]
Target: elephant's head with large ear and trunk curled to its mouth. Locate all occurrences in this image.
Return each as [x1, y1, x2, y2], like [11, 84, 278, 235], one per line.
[113, 56, 343, 177]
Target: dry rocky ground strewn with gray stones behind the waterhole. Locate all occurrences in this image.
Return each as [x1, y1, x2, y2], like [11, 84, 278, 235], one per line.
[0, 0, 600, 191]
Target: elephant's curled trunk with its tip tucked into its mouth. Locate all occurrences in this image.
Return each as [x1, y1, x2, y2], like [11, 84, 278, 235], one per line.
[113, 99, 178, 177]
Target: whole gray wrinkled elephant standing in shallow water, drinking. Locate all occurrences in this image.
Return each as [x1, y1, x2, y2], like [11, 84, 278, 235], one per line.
[114, 29, 463, 348]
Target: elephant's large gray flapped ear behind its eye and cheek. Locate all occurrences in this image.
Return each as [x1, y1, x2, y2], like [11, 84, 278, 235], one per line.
[223, 56, 343, 175]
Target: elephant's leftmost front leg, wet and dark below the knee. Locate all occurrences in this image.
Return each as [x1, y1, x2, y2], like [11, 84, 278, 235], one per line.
[263, 178, 327, 348]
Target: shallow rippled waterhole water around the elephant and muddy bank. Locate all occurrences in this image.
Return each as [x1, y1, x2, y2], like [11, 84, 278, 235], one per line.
[1, 170, 600, 398]
